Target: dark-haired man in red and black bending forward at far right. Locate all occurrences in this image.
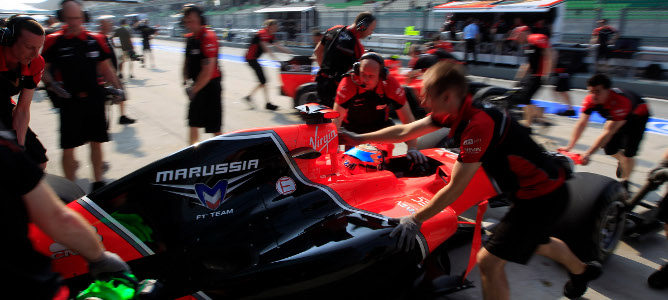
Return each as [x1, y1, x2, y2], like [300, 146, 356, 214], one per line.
[559, 74, 650, 191]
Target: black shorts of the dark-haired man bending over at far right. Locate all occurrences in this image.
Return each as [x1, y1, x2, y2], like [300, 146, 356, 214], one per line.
[603, 115, 649, 157]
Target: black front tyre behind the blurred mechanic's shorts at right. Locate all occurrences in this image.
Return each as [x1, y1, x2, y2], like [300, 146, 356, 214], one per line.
[554, 172, 628, 261]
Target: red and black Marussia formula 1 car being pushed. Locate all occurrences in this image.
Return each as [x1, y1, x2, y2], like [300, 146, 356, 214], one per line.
[30, 104, 624, 299]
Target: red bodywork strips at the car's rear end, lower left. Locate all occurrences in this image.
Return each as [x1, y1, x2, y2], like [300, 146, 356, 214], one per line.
[28, 201, 142, 278]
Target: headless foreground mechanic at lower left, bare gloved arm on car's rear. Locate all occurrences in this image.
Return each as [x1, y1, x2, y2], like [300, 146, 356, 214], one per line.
[0, 124, 130, 300]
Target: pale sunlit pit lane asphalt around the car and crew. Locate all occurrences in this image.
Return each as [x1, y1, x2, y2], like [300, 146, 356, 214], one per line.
[30, 40, 668, 299]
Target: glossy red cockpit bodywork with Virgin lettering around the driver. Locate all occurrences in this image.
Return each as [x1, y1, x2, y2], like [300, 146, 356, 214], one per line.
[232, 123, 497, 251]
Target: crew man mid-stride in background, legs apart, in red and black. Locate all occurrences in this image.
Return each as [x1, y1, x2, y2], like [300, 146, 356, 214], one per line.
[244, 19, 292, 110]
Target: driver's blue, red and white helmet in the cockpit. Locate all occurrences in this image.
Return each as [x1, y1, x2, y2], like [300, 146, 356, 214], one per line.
[343, 144, 384, 175]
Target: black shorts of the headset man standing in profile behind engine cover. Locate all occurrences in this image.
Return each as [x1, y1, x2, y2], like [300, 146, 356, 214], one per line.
[188, 77, 223, 133]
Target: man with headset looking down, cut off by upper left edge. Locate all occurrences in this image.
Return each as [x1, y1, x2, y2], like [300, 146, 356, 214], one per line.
[0, 16, 48, 169]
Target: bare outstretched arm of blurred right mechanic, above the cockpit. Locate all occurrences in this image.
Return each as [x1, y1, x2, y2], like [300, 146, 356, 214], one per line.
[359, 116, 440, 143]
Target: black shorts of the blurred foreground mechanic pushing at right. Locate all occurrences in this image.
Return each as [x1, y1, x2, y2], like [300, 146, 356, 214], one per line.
[484, 184, 569, 264]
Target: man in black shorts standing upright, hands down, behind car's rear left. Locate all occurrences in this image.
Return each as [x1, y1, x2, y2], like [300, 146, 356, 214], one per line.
[42, 0, 124, 190]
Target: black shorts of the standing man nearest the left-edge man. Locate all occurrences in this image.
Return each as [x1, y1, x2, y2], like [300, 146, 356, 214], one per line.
[60, 92, 109, 149]
